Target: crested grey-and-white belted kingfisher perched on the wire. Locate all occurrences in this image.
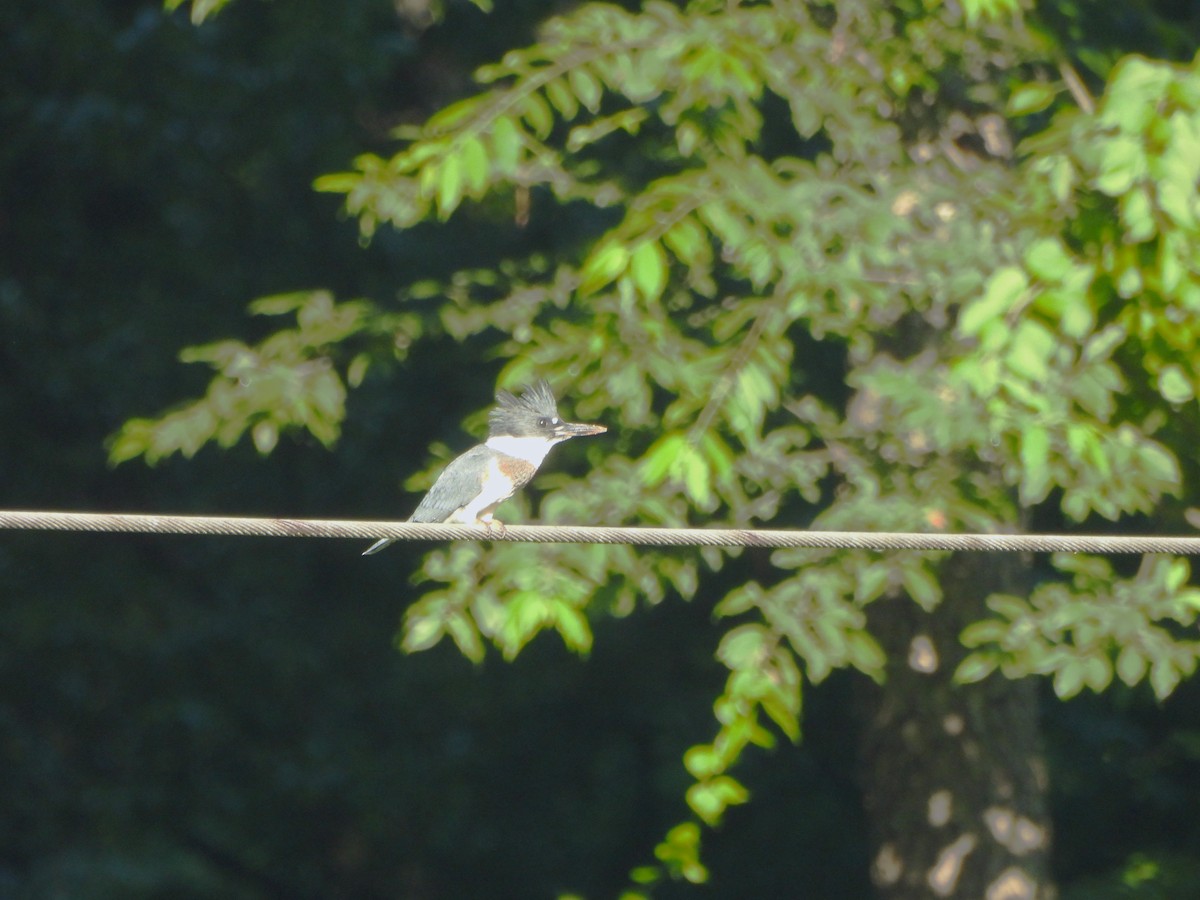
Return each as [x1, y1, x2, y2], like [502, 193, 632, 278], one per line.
[362, 380, 608, 556]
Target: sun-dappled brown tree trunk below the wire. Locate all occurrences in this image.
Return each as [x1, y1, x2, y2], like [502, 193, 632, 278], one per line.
[858, 553, 1055, 900]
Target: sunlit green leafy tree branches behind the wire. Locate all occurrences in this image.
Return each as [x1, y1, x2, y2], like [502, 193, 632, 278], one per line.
[114, 0, 1200, 897]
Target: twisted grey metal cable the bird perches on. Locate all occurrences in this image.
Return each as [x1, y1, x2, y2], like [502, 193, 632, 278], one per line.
[0, 510, 1200, 556]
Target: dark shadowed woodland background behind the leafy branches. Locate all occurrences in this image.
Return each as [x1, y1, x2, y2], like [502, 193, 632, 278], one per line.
[0, 0, 1200, 898]
